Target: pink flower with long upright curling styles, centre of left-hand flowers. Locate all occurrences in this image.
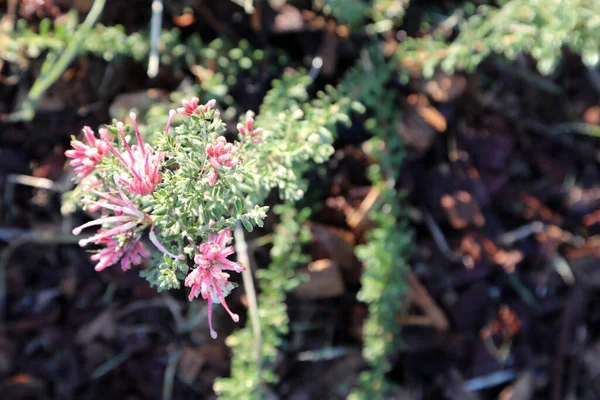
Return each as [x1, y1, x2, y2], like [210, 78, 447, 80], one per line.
[100, 110, 169, 195]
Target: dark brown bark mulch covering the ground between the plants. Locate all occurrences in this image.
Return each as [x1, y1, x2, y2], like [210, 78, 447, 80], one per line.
[0, 1, 600, 400]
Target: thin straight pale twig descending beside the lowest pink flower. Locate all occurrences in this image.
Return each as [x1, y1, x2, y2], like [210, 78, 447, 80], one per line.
[233, 222, 262, 377]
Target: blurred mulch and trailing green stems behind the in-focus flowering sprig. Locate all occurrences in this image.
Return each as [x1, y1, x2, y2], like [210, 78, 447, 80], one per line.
[0, 0, 600, 400]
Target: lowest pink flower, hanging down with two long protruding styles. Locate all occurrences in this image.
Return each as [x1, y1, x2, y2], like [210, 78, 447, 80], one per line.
[185, 229, 244, 339]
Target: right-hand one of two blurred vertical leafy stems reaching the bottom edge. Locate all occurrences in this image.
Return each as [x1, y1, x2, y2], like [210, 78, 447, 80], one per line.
[346, 46, 412, 399]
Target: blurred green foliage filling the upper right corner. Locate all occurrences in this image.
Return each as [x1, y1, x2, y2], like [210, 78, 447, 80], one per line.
[397, 0, 600, 77]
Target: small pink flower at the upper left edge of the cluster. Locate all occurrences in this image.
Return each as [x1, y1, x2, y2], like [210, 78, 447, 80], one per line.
[65, 126, 109, 179]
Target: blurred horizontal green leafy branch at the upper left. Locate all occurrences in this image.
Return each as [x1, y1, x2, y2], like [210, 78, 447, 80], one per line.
[0, 12, 288, 120]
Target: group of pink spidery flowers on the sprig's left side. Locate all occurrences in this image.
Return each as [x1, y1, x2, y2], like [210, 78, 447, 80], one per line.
[65, 112, 180, 271]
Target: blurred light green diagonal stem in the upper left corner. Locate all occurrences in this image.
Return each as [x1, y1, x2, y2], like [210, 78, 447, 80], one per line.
[8, 0, 106, 121]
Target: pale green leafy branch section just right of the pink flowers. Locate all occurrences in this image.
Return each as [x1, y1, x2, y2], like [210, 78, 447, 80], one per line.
[245, 68, 352, 201]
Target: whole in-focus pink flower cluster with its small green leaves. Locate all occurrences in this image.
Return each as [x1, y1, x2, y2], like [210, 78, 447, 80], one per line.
[65, 97, 266, 338]
